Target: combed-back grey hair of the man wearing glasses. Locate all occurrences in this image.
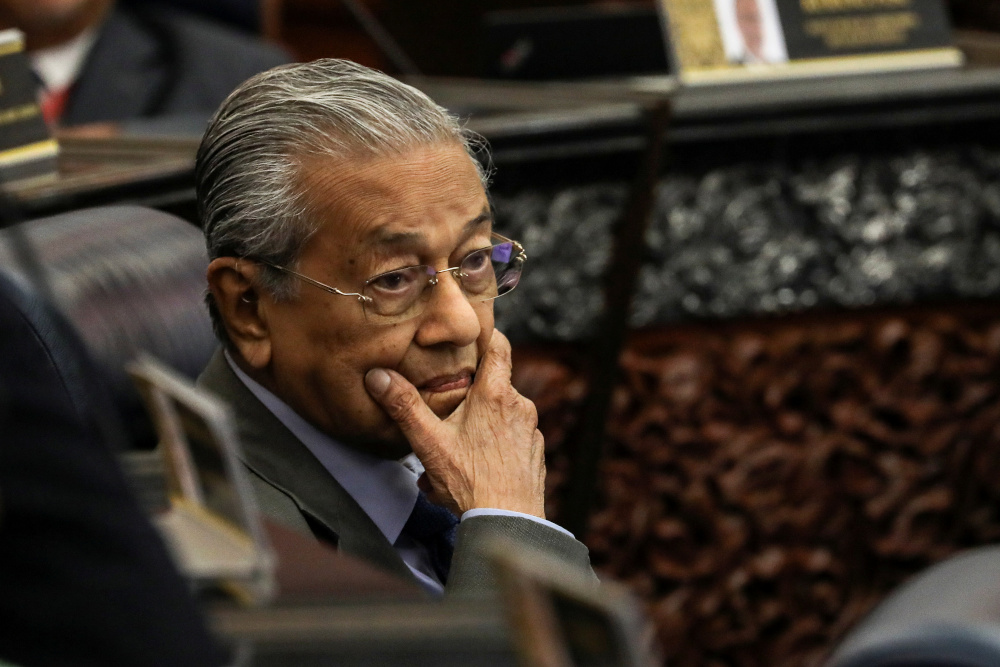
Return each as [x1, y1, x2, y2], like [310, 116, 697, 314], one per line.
[196, 59, 490, 342]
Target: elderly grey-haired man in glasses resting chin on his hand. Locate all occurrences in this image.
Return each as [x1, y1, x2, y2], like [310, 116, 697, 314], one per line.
[197, 60, 590, 594]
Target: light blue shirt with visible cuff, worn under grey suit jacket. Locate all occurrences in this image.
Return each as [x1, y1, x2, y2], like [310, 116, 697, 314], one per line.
[225, 352, 573, 595]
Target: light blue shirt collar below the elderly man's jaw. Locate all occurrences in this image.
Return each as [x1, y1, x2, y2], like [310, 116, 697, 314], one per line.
[225, 351, 423, 544]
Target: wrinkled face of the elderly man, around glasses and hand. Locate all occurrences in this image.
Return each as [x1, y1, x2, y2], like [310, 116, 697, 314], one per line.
[261, 144, 493, 458]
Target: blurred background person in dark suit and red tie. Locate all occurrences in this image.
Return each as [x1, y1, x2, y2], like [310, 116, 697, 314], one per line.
[0, 0, 290, 126]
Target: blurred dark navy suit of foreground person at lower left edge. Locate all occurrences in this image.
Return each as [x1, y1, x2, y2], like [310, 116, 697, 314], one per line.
[0, 268, 222, 667]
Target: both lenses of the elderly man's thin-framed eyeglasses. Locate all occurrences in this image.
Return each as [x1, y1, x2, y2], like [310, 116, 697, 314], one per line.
[361, 241, 523, 319]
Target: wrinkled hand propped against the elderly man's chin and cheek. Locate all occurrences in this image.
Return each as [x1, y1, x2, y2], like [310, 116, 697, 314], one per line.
[365, 331, 545, 519]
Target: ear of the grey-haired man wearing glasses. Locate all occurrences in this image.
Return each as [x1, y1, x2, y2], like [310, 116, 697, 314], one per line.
[206, 257, 271, 370]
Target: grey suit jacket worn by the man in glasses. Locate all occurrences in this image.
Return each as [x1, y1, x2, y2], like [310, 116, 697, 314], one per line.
[198, 351, 596, 596]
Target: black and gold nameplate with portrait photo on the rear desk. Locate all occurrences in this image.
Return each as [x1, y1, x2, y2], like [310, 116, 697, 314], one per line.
[660, 0, 963, 84]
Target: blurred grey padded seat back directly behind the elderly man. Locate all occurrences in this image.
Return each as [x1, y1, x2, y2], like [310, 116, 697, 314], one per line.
[0, 206, 216, 448]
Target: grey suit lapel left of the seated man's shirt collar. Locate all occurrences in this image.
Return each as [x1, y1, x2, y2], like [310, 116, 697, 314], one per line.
[198, 350, 414, 580]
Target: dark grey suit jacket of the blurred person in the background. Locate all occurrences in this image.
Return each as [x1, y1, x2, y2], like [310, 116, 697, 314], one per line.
[61, 4, 291, 125]
